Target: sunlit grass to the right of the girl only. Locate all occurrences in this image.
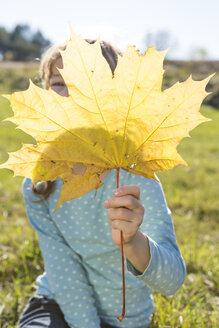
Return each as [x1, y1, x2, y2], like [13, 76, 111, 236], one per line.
[152, 107, 219, 328]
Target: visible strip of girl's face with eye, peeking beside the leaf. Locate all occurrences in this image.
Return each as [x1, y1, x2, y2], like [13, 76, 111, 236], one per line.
[50, 58, 68, 97]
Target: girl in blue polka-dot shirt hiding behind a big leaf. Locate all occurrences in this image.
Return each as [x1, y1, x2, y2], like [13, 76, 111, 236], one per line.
[19, 40, 185, 328]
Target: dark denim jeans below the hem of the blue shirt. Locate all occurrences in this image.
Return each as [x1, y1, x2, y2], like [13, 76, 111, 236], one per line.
[19, 296, 114, 328]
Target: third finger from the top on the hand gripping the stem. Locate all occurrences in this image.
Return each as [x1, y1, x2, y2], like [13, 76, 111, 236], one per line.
[108, 207, 142, 226]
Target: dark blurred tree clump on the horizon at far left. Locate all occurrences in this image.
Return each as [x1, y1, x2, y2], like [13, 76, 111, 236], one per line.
[0, 24, 51, 61]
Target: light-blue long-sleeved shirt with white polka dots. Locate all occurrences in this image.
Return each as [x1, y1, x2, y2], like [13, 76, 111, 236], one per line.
[23, 170, 185, 328]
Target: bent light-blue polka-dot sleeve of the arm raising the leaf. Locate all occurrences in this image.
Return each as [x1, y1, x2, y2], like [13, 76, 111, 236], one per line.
[126, 175, 186, 295]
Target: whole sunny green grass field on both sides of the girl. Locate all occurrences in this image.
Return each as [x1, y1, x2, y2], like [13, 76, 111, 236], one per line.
[0, 73, 219, 328]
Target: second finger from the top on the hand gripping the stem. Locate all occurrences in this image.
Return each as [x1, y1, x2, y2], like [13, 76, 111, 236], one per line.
[104, 195, 142, 210]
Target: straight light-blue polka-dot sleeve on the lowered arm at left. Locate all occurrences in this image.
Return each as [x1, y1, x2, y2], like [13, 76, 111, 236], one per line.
[23, 179, 100, 328]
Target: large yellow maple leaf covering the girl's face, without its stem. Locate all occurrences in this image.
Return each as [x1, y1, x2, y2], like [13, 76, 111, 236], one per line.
[0, 31, 211, 209]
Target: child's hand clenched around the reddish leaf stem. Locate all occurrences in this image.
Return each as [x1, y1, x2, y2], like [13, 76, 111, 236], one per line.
[104, 185, 144, 246]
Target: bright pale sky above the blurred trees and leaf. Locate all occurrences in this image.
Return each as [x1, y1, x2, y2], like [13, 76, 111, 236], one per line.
[0, 0, 219, 60]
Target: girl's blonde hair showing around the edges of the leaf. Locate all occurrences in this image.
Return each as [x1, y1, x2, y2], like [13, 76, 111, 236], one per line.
[32, 39, 122, 201]
